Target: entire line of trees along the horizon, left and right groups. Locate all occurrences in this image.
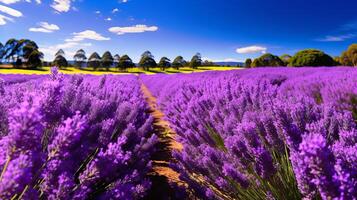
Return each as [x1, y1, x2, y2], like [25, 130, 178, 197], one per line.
[0, 39, 357, 71]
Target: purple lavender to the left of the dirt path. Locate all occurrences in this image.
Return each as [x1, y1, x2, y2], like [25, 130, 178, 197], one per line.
[0, 69, 157, 199]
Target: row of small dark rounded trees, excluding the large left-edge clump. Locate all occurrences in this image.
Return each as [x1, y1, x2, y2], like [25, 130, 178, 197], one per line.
[52, 49, 203, 71]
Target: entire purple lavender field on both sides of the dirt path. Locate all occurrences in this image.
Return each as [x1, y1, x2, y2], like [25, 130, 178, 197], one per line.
[0, 67, 357, 200]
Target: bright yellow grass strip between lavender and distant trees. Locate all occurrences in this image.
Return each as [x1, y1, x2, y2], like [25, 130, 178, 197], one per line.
[0, 66, 242, 75]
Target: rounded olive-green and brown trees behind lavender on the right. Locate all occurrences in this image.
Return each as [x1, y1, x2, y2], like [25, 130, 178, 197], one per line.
[245, 44, 357, 68]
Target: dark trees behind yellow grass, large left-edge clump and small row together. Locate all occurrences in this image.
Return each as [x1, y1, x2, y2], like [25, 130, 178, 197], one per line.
[0, 39, 204, 71]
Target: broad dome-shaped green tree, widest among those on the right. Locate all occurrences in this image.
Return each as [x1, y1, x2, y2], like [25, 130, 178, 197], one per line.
[289, 49, 335, 67]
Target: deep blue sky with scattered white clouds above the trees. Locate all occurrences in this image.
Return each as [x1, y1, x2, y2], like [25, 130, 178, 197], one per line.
[0, 0, 357, 61]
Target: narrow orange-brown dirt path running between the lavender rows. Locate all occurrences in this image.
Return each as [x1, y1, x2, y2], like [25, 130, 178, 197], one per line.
[141, 84, 184, 200]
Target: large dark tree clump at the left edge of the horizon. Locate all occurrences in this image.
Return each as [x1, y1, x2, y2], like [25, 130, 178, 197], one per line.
[0, 39, 43, 69]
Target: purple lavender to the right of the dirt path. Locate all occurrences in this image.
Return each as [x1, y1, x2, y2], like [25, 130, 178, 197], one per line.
[142, 68, 357, 199]
